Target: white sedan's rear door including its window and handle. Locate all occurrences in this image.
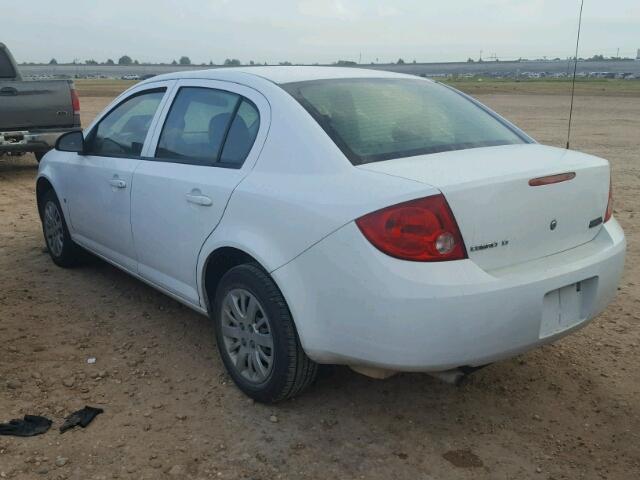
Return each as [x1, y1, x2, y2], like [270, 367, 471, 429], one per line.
[131, 80, 270, 305]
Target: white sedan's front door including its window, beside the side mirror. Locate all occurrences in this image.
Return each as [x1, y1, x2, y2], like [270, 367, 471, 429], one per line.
[66, 82, 173, 271]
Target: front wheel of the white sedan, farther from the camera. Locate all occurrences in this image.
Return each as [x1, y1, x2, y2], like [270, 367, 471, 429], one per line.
[42, 190, 81, 268]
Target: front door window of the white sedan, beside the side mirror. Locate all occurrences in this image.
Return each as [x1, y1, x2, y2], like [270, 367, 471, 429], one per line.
[87, 89, 164, 157]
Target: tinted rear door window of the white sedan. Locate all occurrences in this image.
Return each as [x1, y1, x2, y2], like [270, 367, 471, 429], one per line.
[155, 87, 260, 168]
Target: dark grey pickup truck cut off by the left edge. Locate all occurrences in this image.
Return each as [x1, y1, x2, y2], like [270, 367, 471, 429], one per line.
[0, 43, 80, 161]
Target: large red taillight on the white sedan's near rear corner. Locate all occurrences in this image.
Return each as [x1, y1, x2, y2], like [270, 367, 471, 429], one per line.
[356, 194, 467, 262]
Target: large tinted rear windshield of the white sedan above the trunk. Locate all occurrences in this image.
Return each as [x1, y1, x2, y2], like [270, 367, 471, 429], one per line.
[282, 78, 529, 165]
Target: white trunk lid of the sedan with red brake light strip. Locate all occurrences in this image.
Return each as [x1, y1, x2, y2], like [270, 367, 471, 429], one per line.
[358, 144, 609, 270]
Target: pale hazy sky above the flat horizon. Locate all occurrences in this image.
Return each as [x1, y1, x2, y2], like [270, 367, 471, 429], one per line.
[5, 0, 640, 63]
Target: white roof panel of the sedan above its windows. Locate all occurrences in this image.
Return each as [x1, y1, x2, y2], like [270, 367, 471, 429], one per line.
[143, 65, 416, 84]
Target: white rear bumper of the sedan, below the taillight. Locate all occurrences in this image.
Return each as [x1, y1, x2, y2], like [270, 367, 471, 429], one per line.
[273, 219, 626, 371]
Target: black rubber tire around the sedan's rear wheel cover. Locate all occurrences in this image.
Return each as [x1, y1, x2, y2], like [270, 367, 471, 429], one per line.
[211, 263, 318, 403]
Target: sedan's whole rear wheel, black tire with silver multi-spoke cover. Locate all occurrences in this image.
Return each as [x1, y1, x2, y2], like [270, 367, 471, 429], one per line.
[213, 264, 317, 403]
